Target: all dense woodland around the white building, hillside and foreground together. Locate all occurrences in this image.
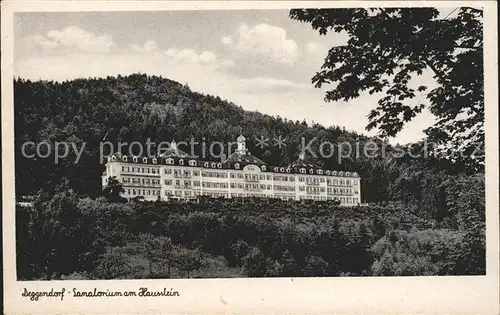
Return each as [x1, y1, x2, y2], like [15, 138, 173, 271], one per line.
[14, 74, 485, 279]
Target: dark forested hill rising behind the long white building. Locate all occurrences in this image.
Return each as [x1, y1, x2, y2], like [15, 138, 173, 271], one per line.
[14, 74, 476, 212]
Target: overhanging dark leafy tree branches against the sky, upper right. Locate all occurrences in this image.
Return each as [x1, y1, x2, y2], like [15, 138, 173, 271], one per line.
[289, 7, 484, 168]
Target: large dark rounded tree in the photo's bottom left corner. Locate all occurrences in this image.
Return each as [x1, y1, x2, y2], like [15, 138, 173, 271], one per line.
[17, 185, 104, 279]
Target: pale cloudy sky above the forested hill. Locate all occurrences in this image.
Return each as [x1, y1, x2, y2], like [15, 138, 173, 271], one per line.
[14, 10, 442, 144]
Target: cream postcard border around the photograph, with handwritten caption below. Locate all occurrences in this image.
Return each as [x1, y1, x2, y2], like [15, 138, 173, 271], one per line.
[1, 1, 500, 314]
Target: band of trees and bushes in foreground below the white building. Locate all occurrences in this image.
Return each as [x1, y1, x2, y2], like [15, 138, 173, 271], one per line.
[16, 176, 485, 279]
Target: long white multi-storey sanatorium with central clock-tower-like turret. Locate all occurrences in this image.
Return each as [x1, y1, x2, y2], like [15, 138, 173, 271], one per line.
[102, 136, 361, 205]
